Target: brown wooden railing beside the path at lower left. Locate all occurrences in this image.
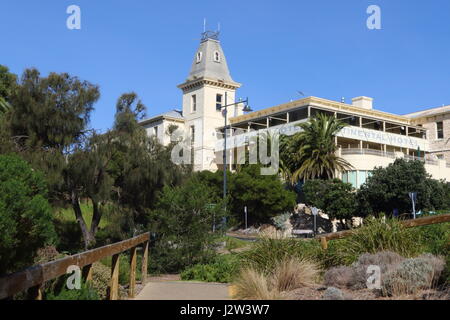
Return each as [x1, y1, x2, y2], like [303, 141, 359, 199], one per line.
[0, 233, 150, 300]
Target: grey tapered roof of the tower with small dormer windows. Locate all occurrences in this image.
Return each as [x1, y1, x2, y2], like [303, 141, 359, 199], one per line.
[186, 31, 236, 84]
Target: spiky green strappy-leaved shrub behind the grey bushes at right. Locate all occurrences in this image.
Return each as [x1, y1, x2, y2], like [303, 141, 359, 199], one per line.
[332, 218, 423, 265]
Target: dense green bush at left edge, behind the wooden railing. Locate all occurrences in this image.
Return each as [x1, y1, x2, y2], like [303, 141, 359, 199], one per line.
[0, 155, 55, 274]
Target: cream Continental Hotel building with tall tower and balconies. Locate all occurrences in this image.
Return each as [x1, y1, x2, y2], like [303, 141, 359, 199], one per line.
[141, 32, 450, 188]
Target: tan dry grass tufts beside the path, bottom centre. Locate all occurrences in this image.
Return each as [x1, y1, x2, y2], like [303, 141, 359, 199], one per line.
[233, 258, 319, 300]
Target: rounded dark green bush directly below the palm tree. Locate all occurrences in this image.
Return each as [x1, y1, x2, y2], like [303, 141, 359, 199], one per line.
[303, 179, 357, 220]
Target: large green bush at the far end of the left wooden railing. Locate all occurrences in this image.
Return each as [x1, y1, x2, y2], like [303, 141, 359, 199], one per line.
[149, 177, 224, 273]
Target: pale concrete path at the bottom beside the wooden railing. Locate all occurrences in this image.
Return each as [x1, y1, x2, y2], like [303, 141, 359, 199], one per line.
[135, 281, 230, 300]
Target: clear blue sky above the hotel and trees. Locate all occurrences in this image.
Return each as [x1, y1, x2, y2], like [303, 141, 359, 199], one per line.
[0, 0, 450, 130]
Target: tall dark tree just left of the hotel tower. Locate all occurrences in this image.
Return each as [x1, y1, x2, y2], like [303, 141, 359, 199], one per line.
[111, 93, 191, 230]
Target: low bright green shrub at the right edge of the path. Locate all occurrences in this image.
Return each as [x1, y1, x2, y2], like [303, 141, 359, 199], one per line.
[181, 255, 238, 283]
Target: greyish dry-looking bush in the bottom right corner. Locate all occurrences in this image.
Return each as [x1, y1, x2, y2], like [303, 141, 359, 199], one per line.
[382, 255, 444, 296]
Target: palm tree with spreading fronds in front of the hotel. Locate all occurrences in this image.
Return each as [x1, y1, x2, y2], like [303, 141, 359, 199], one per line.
[281, 114, 352, 184]
